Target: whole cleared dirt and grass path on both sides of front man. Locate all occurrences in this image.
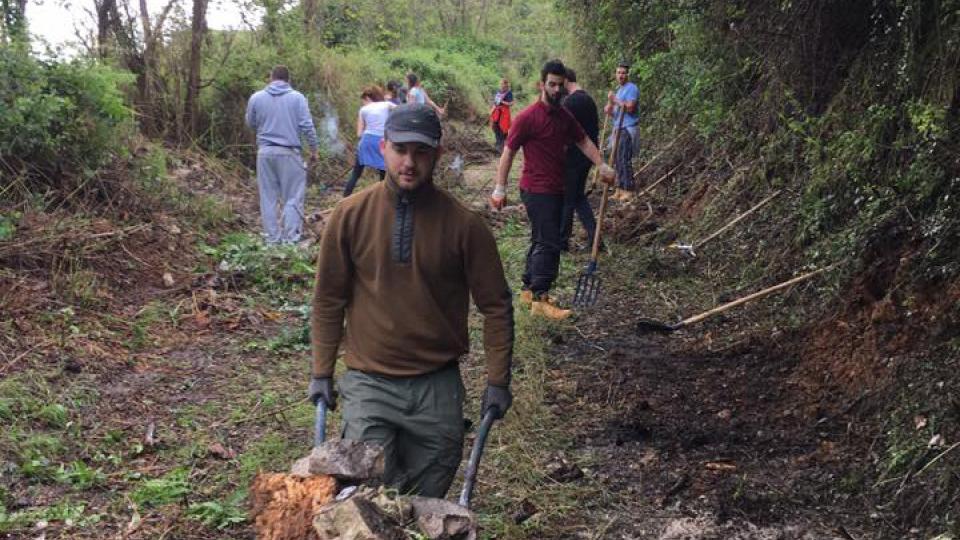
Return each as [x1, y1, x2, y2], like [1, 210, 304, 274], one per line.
[0, 139, 884, 540]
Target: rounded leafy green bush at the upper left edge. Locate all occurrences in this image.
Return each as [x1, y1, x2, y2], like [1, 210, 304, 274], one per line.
[0, 46, 133, 190]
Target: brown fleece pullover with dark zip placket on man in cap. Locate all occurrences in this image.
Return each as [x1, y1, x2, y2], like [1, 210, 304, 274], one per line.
[311, 179, 513, 385]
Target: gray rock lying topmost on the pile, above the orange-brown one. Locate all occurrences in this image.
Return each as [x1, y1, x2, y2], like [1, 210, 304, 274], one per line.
[290, 439, 383, 482]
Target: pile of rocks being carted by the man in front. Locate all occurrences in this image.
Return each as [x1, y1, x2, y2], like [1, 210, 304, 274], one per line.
[250, 440, 477, 540]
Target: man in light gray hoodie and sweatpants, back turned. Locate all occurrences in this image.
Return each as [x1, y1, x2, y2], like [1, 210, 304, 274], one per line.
[246, 66, 317, 244]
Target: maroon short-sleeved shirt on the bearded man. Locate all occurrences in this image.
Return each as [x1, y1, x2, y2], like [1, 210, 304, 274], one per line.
[507, 100, 586, 195]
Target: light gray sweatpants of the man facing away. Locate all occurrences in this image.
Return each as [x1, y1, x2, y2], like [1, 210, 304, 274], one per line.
[257, 146, 307, 244]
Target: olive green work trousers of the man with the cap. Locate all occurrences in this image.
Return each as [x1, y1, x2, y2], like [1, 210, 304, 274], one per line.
[339, 362, 465, 498]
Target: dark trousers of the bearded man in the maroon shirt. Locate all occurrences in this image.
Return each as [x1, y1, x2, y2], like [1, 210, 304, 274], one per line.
[520, 191, 563, 296]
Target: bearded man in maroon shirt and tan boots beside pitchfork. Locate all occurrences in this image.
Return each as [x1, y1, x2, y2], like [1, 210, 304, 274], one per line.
[490, 60, 615, 319]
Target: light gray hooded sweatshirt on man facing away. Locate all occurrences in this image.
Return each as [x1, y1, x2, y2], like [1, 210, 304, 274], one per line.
[247, 81, 317, 150]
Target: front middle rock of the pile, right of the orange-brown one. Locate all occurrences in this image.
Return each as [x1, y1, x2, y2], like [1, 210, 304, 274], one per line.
[313, 496, 406, 540]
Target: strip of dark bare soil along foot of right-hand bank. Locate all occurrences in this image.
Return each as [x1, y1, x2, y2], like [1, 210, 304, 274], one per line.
[456, 153, 869, 540]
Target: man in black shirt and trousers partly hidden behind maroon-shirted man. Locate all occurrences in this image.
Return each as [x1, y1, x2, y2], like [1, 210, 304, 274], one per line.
[560, 68, 600, 251]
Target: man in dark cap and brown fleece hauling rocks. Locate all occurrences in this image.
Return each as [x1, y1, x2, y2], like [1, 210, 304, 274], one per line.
[309, 104, 513, 497]
